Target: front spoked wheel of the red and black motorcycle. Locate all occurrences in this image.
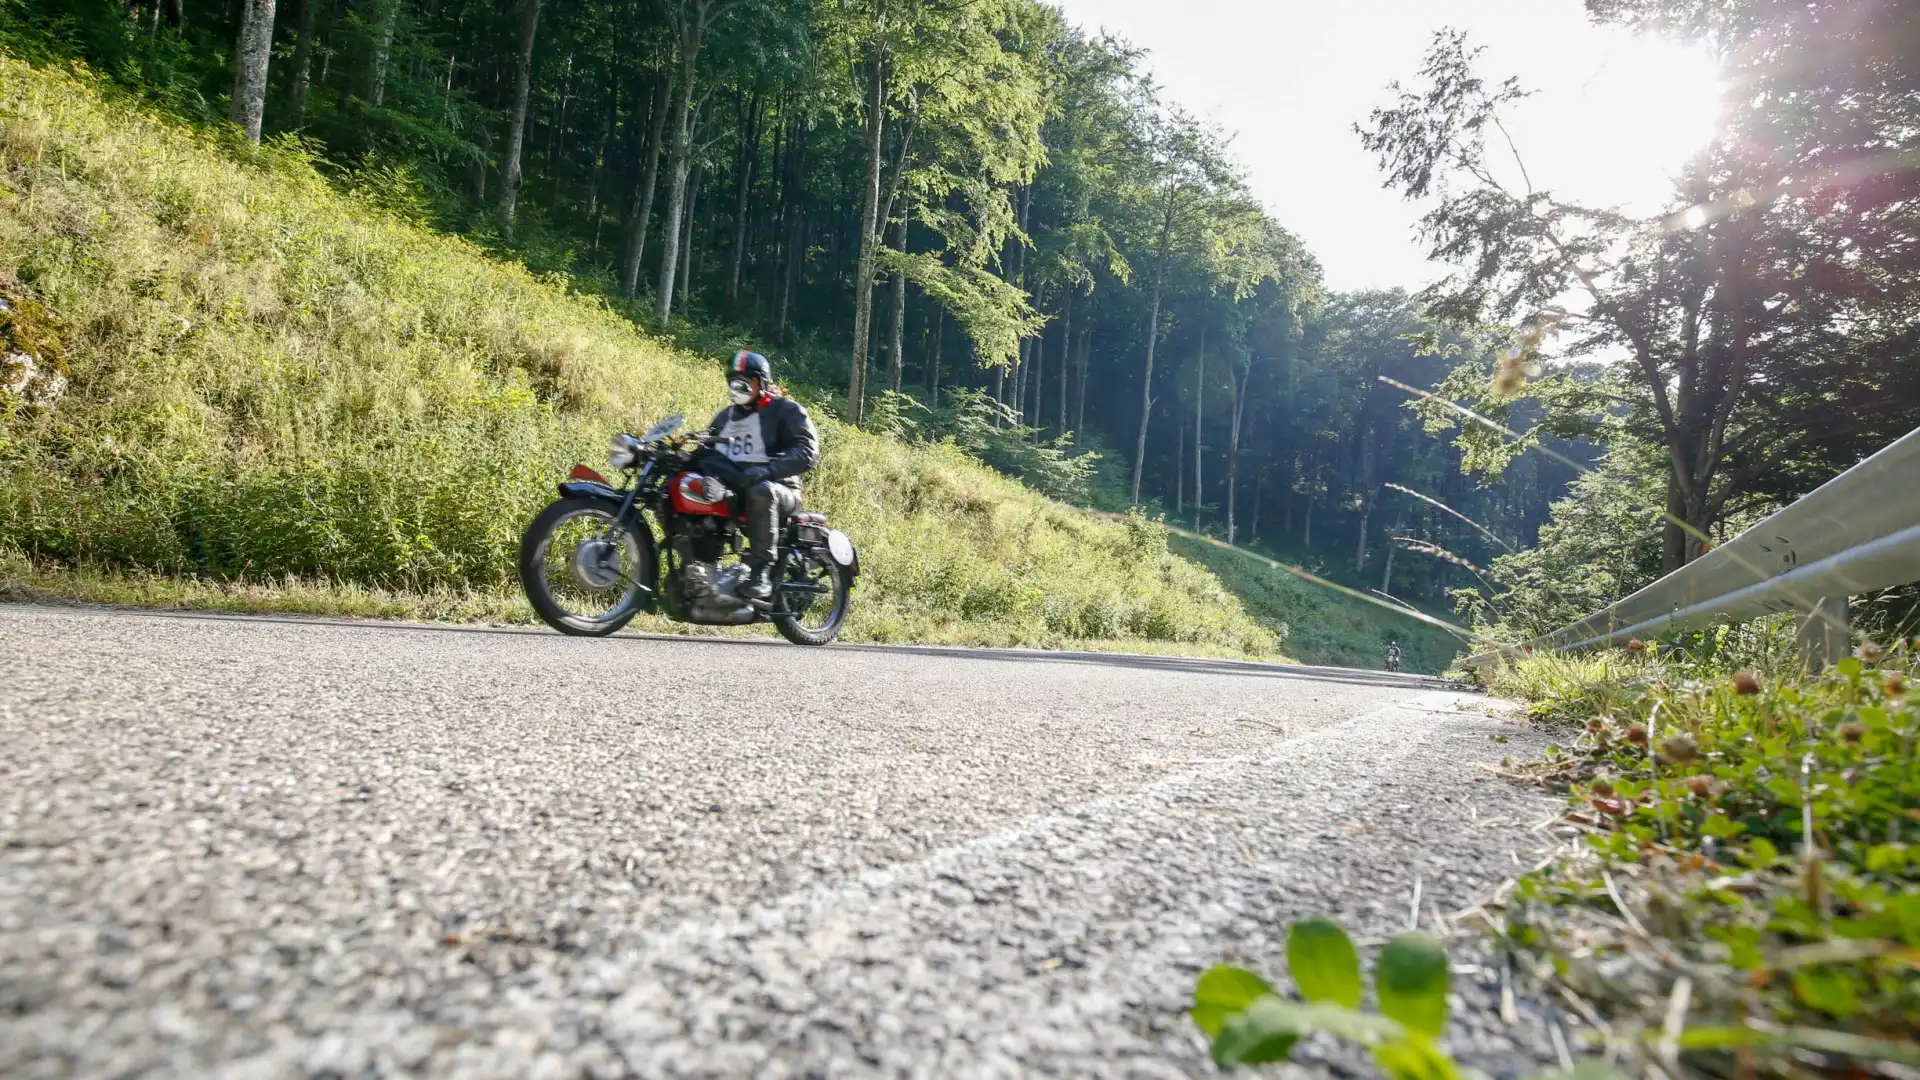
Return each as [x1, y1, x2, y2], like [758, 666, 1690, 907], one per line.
[520, 498, 653, 638]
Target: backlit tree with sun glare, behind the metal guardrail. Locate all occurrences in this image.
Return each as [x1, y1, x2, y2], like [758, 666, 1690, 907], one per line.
[1359, 12, 1920, 573]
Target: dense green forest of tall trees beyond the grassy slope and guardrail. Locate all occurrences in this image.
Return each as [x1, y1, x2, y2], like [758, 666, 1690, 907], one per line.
[4, 0, 1920, 630]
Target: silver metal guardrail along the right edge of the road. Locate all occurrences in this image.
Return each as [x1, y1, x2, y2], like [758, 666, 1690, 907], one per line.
[1467, 429, 1920, 667]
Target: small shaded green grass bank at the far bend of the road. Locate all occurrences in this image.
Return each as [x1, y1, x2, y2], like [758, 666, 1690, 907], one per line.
[1171, 536, 1463, 673]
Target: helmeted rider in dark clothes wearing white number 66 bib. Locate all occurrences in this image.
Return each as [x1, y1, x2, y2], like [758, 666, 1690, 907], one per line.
[708, 350, 820, 600]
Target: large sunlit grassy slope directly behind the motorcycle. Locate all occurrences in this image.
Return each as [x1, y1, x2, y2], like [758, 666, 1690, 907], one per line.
[0, 56, 1277, 655]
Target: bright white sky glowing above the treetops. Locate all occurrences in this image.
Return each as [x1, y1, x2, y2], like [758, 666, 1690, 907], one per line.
[1054, 0, 1718, 290]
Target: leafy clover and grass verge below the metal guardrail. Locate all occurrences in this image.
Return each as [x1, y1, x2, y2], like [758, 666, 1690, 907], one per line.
[1492, 644, 1920, 1076]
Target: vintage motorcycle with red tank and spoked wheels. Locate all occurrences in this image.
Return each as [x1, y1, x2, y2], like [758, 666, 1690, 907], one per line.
[520, 415, 860, 646]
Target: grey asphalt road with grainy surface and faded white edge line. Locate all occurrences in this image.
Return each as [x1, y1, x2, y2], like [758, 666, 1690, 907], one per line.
[0, 605, 1553, 1078]
